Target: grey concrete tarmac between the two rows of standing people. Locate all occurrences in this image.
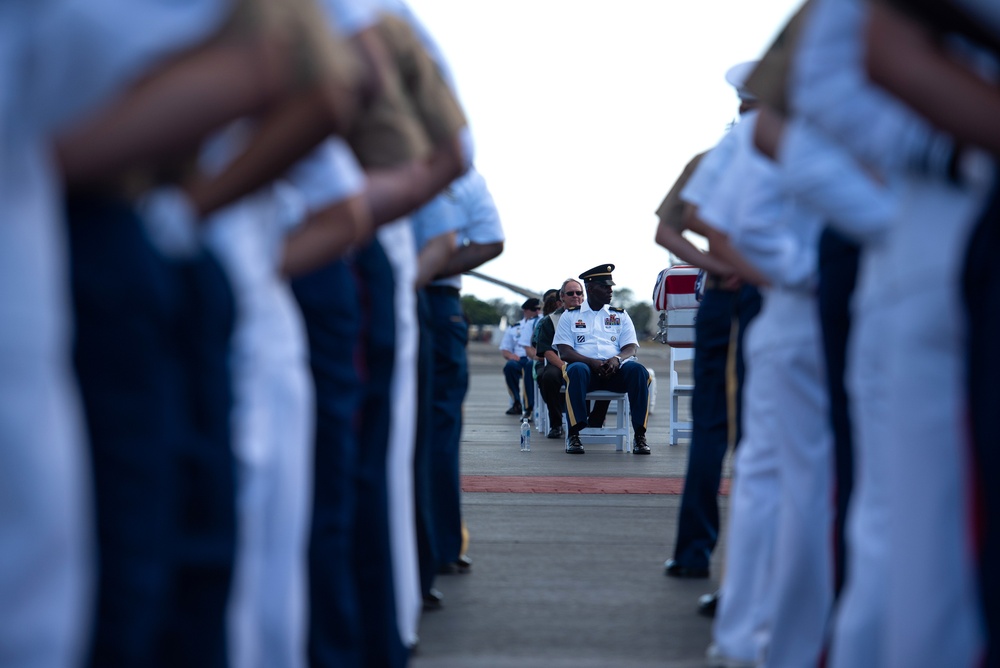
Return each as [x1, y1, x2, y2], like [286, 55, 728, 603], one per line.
[411, 342, 728, 668]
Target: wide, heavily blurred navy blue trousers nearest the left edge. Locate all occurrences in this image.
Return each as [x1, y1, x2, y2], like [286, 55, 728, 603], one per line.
[67, 196, 236, 667]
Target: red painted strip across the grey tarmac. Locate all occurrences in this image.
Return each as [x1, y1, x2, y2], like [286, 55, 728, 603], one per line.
[462, 475, 729, 495]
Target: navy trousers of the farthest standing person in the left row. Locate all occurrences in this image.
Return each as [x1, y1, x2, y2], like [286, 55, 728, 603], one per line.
[427, 289, 466, 566]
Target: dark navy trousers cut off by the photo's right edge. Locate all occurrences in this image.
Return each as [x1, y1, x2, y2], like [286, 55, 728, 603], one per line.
[963, 177, 1000, 666]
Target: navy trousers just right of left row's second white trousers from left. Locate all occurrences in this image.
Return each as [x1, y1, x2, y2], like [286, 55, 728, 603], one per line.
[292, 261, 363, 668]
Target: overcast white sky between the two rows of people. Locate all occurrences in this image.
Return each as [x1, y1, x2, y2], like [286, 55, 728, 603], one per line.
[410, 0, 800, 301]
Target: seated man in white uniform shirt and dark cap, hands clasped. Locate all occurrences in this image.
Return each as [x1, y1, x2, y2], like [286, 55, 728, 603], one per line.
[553, 264, 649, 455]
